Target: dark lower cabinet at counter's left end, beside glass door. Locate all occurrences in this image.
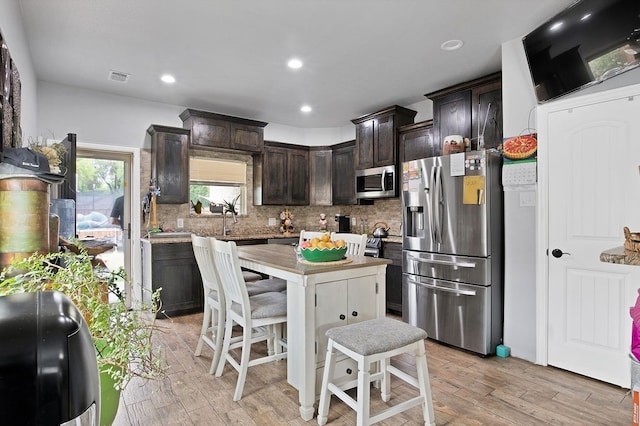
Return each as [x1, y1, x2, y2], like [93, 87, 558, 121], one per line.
[142, 241, 204, 318]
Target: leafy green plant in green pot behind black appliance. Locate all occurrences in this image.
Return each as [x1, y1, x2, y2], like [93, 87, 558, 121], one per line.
[0, 248, 168, 425]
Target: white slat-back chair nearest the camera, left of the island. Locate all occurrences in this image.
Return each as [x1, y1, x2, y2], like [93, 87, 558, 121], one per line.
[211, 240, 287, 401]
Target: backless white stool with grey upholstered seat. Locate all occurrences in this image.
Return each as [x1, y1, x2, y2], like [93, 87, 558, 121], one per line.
[318, 318, 436, 426]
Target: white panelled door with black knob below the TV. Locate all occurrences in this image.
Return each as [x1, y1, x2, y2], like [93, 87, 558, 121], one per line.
[543, 92, 640, 387]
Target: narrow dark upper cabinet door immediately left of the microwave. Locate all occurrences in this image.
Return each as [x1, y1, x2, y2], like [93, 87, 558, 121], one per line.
[331, 141, 356, 205]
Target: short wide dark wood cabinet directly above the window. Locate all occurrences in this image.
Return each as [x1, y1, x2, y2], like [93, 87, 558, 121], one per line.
[180, 109, 267, 152]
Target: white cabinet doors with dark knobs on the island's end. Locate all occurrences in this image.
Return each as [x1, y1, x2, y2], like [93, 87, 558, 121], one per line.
[315, 276, 378, 362]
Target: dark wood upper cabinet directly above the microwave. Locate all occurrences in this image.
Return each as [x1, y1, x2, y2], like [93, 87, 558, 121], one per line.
[351, 105, 416, 170]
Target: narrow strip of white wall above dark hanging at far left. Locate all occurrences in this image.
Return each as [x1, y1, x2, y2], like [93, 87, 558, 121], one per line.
[0, 0, 38, 140]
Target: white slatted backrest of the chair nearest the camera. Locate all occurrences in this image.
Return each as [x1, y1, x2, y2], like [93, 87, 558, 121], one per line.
[210, 239, 251, 319]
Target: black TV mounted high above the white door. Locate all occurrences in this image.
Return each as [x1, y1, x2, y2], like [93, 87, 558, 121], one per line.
[522, 0, 640, 103]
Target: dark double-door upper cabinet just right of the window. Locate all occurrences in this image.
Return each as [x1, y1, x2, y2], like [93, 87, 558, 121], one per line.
[253, 142, 309, 206]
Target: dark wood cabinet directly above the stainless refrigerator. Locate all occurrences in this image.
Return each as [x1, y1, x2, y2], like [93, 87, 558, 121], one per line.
[425, 72, 502, 155]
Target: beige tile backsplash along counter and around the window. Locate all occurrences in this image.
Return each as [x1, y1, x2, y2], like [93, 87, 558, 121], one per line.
[140, 150, 402, 236]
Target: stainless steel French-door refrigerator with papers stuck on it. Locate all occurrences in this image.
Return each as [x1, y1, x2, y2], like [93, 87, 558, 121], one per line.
[402, 150, 502, 355]
